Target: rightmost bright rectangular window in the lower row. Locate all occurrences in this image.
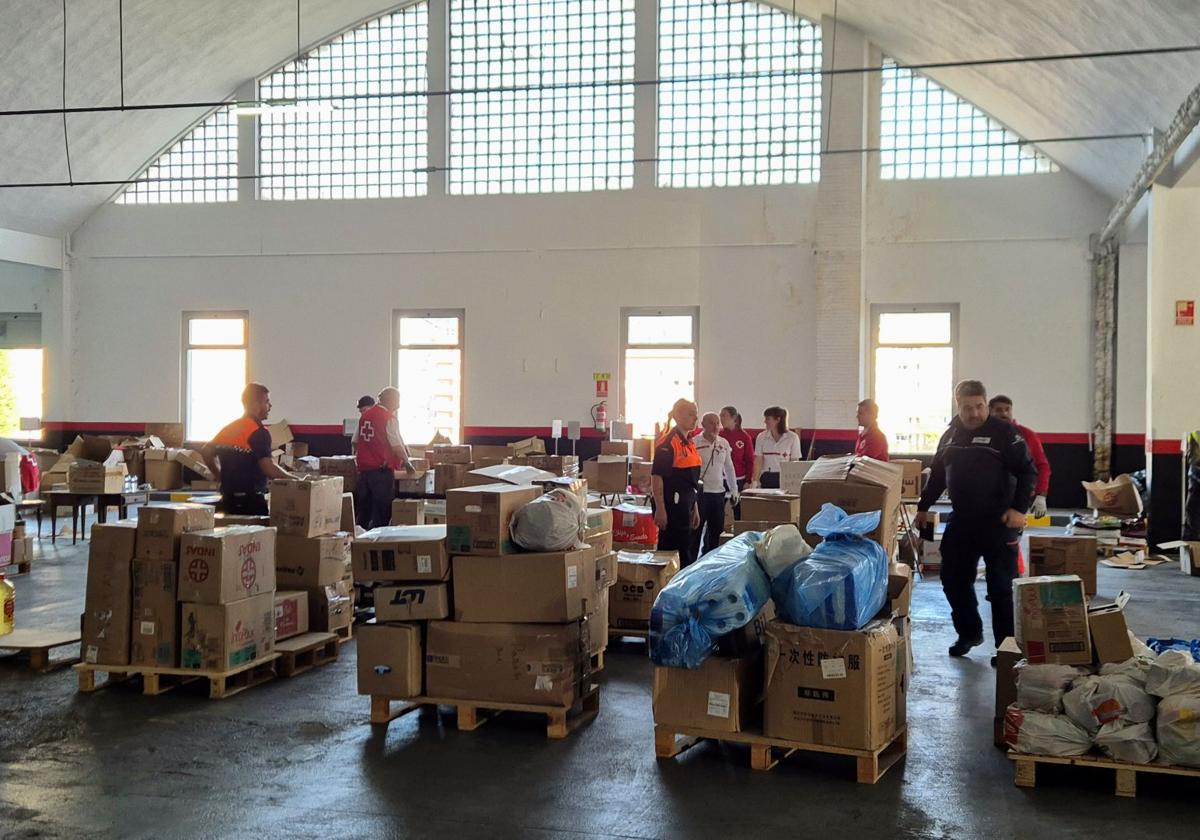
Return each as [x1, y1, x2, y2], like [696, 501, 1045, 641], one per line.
[871, 306, 958, 454]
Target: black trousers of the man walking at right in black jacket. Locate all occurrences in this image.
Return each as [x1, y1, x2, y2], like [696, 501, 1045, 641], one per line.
[942, 514, 1021, 647]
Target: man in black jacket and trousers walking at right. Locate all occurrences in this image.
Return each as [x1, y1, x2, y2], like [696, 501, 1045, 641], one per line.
[913, 379, 1038, 665]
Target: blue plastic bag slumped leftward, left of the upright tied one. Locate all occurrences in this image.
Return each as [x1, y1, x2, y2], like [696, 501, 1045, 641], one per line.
[650, 532, 770, 668]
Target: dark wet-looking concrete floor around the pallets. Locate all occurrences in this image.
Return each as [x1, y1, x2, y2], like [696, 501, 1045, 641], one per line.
[7, 520, 1200, 840]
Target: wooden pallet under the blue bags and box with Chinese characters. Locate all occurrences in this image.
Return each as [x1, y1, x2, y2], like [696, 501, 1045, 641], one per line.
[654, 725, 908, 785]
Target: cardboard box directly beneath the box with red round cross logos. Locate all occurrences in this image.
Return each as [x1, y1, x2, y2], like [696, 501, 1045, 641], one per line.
[180, 592, 275, 672]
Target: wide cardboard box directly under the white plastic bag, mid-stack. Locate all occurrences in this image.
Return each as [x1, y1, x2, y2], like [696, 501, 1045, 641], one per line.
[454, 547, 596, 623]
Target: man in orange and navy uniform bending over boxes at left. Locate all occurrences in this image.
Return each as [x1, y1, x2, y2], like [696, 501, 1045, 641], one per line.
[200, 382, 295, 516]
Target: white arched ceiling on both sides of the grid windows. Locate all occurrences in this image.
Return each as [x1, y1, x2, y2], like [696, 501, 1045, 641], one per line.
[0, 0, 1200, 235]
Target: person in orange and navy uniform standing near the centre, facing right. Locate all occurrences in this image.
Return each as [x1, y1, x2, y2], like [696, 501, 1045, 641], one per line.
[650, 400, 702, 568]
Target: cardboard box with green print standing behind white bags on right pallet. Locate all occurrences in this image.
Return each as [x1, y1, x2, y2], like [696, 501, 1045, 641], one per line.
[1013, 575, 1092, 665]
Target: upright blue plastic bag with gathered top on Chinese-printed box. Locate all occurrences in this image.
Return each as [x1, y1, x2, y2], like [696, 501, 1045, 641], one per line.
[772, 502, 888, 630]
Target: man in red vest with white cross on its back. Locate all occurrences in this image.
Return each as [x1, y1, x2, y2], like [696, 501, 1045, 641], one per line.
[354, 388, 414, 530]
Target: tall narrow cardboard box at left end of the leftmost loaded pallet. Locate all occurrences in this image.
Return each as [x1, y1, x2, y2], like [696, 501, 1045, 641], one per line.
[79, 521, 137, 665]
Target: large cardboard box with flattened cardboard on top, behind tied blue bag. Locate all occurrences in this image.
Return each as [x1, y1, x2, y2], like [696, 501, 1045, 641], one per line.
[796, 455, 904, 553]
